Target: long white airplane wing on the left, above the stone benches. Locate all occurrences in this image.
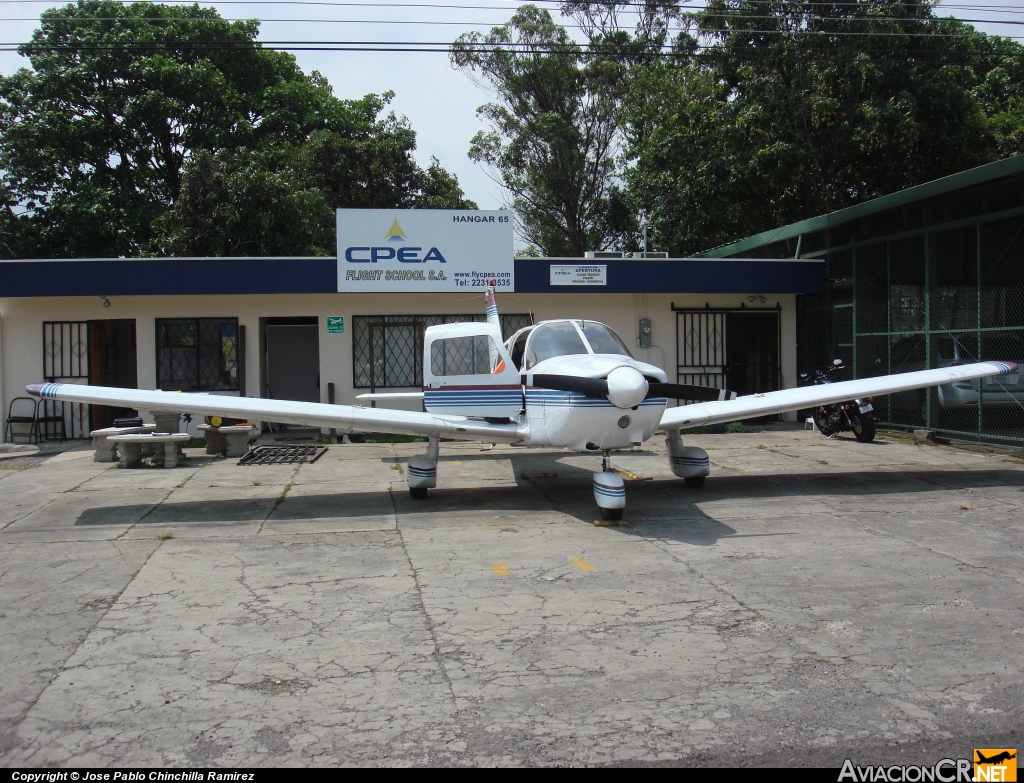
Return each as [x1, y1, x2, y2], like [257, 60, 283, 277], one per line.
[26, 383, 520, 442]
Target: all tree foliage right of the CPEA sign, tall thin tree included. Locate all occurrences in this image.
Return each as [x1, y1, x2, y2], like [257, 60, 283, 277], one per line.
[453, 0, 1024, 255]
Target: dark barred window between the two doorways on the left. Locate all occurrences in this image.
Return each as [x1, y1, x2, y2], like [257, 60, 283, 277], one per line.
[157, 318, 239, 392]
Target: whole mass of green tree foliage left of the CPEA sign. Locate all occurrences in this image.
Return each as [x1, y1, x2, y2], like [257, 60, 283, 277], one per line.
[0, 0, 473, 257]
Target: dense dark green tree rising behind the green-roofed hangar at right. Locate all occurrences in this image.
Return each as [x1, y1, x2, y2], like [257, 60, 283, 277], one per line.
[623, 0, 1024, 254]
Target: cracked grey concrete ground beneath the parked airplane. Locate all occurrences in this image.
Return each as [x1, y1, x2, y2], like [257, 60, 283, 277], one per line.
[0, 428, 1024, 767]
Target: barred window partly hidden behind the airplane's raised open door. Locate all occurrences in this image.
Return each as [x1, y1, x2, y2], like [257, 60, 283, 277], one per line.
[352, 313, 534, 389]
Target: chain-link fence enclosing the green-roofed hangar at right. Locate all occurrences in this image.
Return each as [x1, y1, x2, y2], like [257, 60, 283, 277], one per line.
[798, 211, 1024, 444]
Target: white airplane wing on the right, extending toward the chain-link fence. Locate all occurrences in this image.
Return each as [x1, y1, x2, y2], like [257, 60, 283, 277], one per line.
[660, 361, 1017, 430]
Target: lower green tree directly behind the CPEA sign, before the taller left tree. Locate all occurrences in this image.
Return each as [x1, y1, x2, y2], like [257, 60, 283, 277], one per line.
[156, 94, 477, 256]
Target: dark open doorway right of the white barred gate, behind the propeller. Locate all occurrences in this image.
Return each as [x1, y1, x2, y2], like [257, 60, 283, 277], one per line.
[725, 310, 779, 396]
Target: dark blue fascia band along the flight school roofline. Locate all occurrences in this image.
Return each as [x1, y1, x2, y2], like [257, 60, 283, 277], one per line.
[0, 256, 824, 297]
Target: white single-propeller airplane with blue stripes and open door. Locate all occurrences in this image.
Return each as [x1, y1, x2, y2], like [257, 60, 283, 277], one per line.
[26, 288, 1017, 520]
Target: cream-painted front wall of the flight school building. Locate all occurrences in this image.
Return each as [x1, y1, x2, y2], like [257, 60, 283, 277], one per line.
[0, 293, 797, 433]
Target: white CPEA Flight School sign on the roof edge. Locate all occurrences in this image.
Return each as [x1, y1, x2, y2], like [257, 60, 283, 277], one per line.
[338, 210, 515, 293]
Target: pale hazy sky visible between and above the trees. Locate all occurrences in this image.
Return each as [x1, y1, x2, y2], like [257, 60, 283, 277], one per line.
[0, 0, 1024, 209]
